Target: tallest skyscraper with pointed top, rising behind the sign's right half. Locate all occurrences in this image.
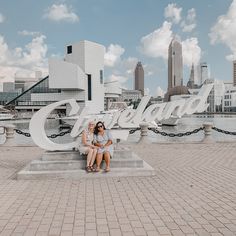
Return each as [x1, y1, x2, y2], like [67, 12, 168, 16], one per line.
[168, 38, 183, 90]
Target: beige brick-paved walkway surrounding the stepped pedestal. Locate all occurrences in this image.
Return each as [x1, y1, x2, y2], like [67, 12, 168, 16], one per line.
[0, 143, 236, 236]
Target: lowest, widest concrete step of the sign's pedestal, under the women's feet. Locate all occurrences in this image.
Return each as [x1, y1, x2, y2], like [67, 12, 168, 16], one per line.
[17, 162, 156, 180]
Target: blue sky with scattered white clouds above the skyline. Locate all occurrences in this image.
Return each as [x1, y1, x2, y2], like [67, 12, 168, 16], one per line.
[0, 0, 236, 95]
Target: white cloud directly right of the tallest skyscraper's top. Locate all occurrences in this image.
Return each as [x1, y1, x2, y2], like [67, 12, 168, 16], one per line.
[182, 38, 201, 67]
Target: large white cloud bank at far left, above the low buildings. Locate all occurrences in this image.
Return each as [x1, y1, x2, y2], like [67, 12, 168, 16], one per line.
[0, 35, 48, 81]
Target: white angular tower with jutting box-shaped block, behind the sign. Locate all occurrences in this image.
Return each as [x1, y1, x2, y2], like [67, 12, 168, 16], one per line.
[48, 41, 105, 113]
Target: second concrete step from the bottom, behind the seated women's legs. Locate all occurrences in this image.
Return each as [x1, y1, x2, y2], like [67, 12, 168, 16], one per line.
[29, 157, 143, 171]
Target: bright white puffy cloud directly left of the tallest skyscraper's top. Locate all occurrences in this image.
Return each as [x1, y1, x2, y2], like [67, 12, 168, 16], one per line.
[141, 21, 173, 59]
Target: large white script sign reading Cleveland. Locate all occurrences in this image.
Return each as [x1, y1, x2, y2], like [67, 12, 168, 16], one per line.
[29, 84, 213, 151]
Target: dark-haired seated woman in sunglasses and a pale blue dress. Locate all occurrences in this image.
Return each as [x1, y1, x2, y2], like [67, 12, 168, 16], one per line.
[94, 121, 113, 172]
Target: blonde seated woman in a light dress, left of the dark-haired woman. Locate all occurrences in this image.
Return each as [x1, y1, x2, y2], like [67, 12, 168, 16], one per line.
[79, 121, 98, 172]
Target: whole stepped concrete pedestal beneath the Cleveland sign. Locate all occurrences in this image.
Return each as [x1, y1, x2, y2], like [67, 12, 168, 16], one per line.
[17, 146, 155, 179]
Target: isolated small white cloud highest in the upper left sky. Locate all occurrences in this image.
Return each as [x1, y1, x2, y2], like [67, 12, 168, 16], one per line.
[44, 4, 79, 23]
